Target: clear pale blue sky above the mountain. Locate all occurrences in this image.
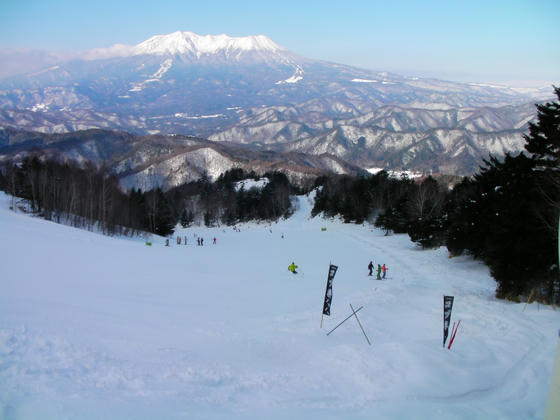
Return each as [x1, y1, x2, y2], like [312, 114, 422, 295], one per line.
[0, 0, 560, 84]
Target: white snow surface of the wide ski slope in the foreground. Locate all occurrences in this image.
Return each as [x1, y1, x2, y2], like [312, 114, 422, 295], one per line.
[0, 195, 560, 419]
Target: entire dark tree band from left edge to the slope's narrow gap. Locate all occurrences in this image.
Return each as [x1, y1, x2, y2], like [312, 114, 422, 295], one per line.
[0, 156, 297, 236]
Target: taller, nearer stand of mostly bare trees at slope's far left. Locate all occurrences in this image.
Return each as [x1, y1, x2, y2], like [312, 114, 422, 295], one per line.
[0, 156, 179, 235]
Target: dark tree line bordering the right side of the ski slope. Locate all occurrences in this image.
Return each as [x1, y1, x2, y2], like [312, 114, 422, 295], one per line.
[313, 88, 560, 303]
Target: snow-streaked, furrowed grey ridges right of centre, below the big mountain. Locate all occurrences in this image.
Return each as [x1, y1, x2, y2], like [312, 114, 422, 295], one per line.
[209, 104, 535, 175]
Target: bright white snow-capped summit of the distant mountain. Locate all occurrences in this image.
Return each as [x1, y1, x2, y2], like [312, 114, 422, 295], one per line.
[133, 31, 284, 56]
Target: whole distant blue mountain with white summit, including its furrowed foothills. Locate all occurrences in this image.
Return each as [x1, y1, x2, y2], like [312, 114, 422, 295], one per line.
[0, 32, 552, 173]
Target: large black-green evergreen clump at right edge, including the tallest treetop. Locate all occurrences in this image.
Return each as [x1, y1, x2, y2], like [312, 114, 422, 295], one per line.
[447, 88, 560, 301]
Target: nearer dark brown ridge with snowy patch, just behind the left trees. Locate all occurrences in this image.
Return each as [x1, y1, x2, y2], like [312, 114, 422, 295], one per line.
[0, 129, 363, 191]
